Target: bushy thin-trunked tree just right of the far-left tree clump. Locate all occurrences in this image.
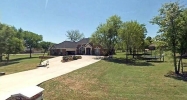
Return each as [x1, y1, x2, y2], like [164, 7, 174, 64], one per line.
[23, 31, 42, 58]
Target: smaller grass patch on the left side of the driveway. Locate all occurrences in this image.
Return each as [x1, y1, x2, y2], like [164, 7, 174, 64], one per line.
[0, 54, 41, 75]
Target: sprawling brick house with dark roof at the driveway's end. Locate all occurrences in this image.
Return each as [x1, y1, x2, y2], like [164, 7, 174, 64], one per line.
[50, 38, 106, 56]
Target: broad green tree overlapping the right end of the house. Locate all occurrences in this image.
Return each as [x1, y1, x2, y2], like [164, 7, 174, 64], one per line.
[91, 15, 122, 55]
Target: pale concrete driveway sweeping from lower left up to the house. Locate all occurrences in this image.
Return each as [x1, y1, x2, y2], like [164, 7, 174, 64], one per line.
[0, 56, 99, 100]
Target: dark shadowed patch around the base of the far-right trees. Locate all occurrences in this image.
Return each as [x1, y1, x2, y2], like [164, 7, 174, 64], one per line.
[164, 71, 187, 82]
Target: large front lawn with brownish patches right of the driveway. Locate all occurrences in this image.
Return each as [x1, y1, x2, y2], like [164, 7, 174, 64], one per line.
[40, 54, 187, 100]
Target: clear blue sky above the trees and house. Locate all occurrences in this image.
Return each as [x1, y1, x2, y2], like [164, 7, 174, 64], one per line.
[0, 0, 187, 43]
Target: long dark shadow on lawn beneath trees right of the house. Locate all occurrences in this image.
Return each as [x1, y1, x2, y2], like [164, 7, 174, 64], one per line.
[103, 57, 154, 66]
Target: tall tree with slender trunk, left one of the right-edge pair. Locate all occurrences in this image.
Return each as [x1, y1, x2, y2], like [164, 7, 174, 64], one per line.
[151, 2, 184, 74]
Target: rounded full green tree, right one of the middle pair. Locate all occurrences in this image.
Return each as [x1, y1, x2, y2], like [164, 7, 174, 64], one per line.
[119, 21, 147, 58]
